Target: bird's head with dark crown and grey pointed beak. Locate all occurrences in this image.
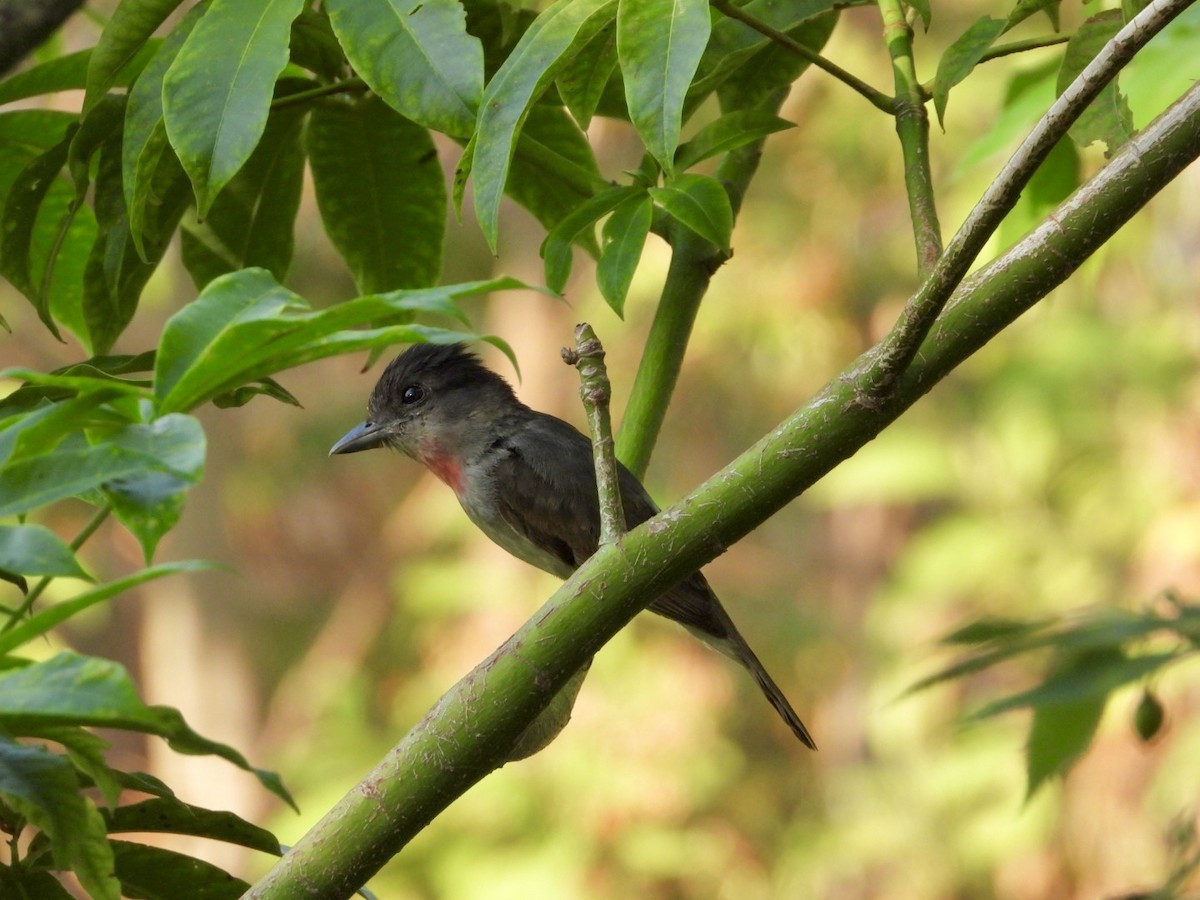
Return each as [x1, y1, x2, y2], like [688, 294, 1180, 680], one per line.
[329, 343, 517, 481]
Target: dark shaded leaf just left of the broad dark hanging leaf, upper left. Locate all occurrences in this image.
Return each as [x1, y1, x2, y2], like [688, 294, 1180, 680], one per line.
[180, 92, 306, 288]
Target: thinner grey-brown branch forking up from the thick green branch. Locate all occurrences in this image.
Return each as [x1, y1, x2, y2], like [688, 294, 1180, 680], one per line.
[859, 0, 1192, 406]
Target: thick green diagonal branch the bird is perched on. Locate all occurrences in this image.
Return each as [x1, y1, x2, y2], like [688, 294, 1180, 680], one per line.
[246, 74, 1200, 900]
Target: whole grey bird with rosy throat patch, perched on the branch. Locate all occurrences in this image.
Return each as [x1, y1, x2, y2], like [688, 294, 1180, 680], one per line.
[330, 343, 816, 750]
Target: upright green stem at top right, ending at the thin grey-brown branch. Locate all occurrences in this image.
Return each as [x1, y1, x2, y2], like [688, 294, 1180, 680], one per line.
[878, 0, 942, 278]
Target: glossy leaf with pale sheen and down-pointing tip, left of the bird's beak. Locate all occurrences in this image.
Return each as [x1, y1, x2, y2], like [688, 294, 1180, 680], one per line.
[103, 413, 205, 563]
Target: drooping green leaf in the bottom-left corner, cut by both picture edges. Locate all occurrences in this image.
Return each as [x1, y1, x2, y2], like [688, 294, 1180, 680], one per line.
[0, 734, 121, 900]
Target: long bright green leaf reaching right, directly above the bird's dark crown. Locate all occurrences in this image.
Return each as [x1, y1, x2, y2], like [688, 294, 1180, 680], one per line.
[155, 269, 524, 413]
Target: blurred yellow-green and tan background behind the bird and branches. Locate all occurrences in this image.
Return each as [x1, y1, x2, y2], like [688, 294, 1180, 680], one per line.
[0, 2, 1200, 900]
